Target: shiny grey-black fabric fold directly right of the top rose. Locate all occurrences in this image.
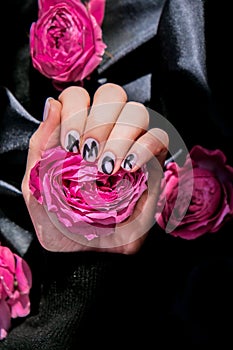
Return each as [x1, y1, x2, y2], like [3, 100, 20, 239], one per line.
[98, 0, 166, 74]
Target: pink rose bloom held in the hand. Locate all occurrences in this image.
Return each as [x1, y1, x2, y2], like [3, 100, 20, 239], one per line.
[29, 146, 147, 240]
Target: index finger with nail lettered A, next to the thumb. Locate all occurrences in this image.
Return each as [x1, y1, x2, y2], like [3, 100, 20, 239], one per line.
[58, 86, 90, 152]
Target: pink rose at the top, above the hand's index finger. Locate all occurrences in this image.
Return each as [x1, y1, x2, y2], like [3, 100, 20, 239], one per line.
[30, 0, 106, 88]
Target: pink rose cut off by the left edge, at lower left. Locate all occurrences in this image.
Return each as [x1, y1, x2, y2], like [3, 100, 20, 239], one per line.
[0, 246, 32, 339]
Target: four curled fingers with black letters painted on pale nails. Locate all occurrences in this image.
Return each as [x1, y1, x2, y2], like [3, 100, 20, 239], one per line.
[59, 84, 168, 175]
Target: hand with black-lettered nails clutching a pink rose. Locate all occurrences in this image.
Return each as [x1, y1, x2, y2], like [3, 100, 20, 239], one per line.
[22, 84, 168, 254]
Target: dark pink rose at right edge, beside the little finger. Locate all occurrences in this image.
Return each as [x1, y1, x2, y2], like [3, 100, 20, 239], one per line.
[155, 146, 233, 239]
